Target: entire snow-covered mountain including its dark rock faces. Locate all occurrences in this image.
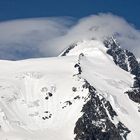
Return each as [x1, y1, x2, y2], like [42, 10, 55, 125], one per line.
[0, 38, 140, 140]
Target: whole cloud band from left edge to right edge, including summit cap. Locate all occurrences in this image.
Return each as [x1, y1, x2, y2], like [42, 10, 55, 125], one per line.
[0, 14, 140, 60]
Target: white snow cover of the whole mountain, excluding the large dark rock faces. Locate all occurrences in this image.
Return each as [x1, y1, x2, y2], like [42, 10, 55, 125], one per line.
[0, 40, 140, 140]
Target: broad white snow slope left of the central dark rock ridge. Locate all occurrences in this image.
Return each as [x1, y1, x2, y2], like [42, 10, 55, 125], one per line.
[0, 58, 87, 140]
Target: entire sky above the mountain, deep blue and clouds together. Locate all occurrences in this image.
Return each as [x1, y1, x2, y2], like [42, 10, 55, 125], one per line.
[0, 0, 140, 60]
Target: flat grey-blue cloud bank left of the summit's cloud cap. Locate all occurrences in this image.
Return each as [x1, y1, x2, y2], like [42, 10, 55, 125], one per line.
[0, 17, 72, 60]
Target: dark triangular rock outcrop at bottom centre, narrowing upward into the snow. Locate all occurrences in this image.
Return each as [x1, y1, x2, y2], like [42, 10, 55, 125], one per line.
[74, 57, 130, 140]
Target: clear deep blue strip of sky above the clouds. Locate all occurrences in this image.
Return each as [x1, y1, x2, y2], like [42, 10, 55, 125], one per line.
[0, 0, 140, 29]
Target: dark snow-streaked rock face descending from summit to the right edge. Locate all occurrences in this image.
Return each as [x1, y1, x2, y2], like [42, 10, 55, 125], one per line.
[104, 38, 140, 103]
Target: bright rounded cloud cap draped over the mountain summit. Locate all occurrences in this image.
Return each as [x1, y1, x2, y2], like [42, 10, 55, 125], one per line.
[48, 14, 140, 57]
